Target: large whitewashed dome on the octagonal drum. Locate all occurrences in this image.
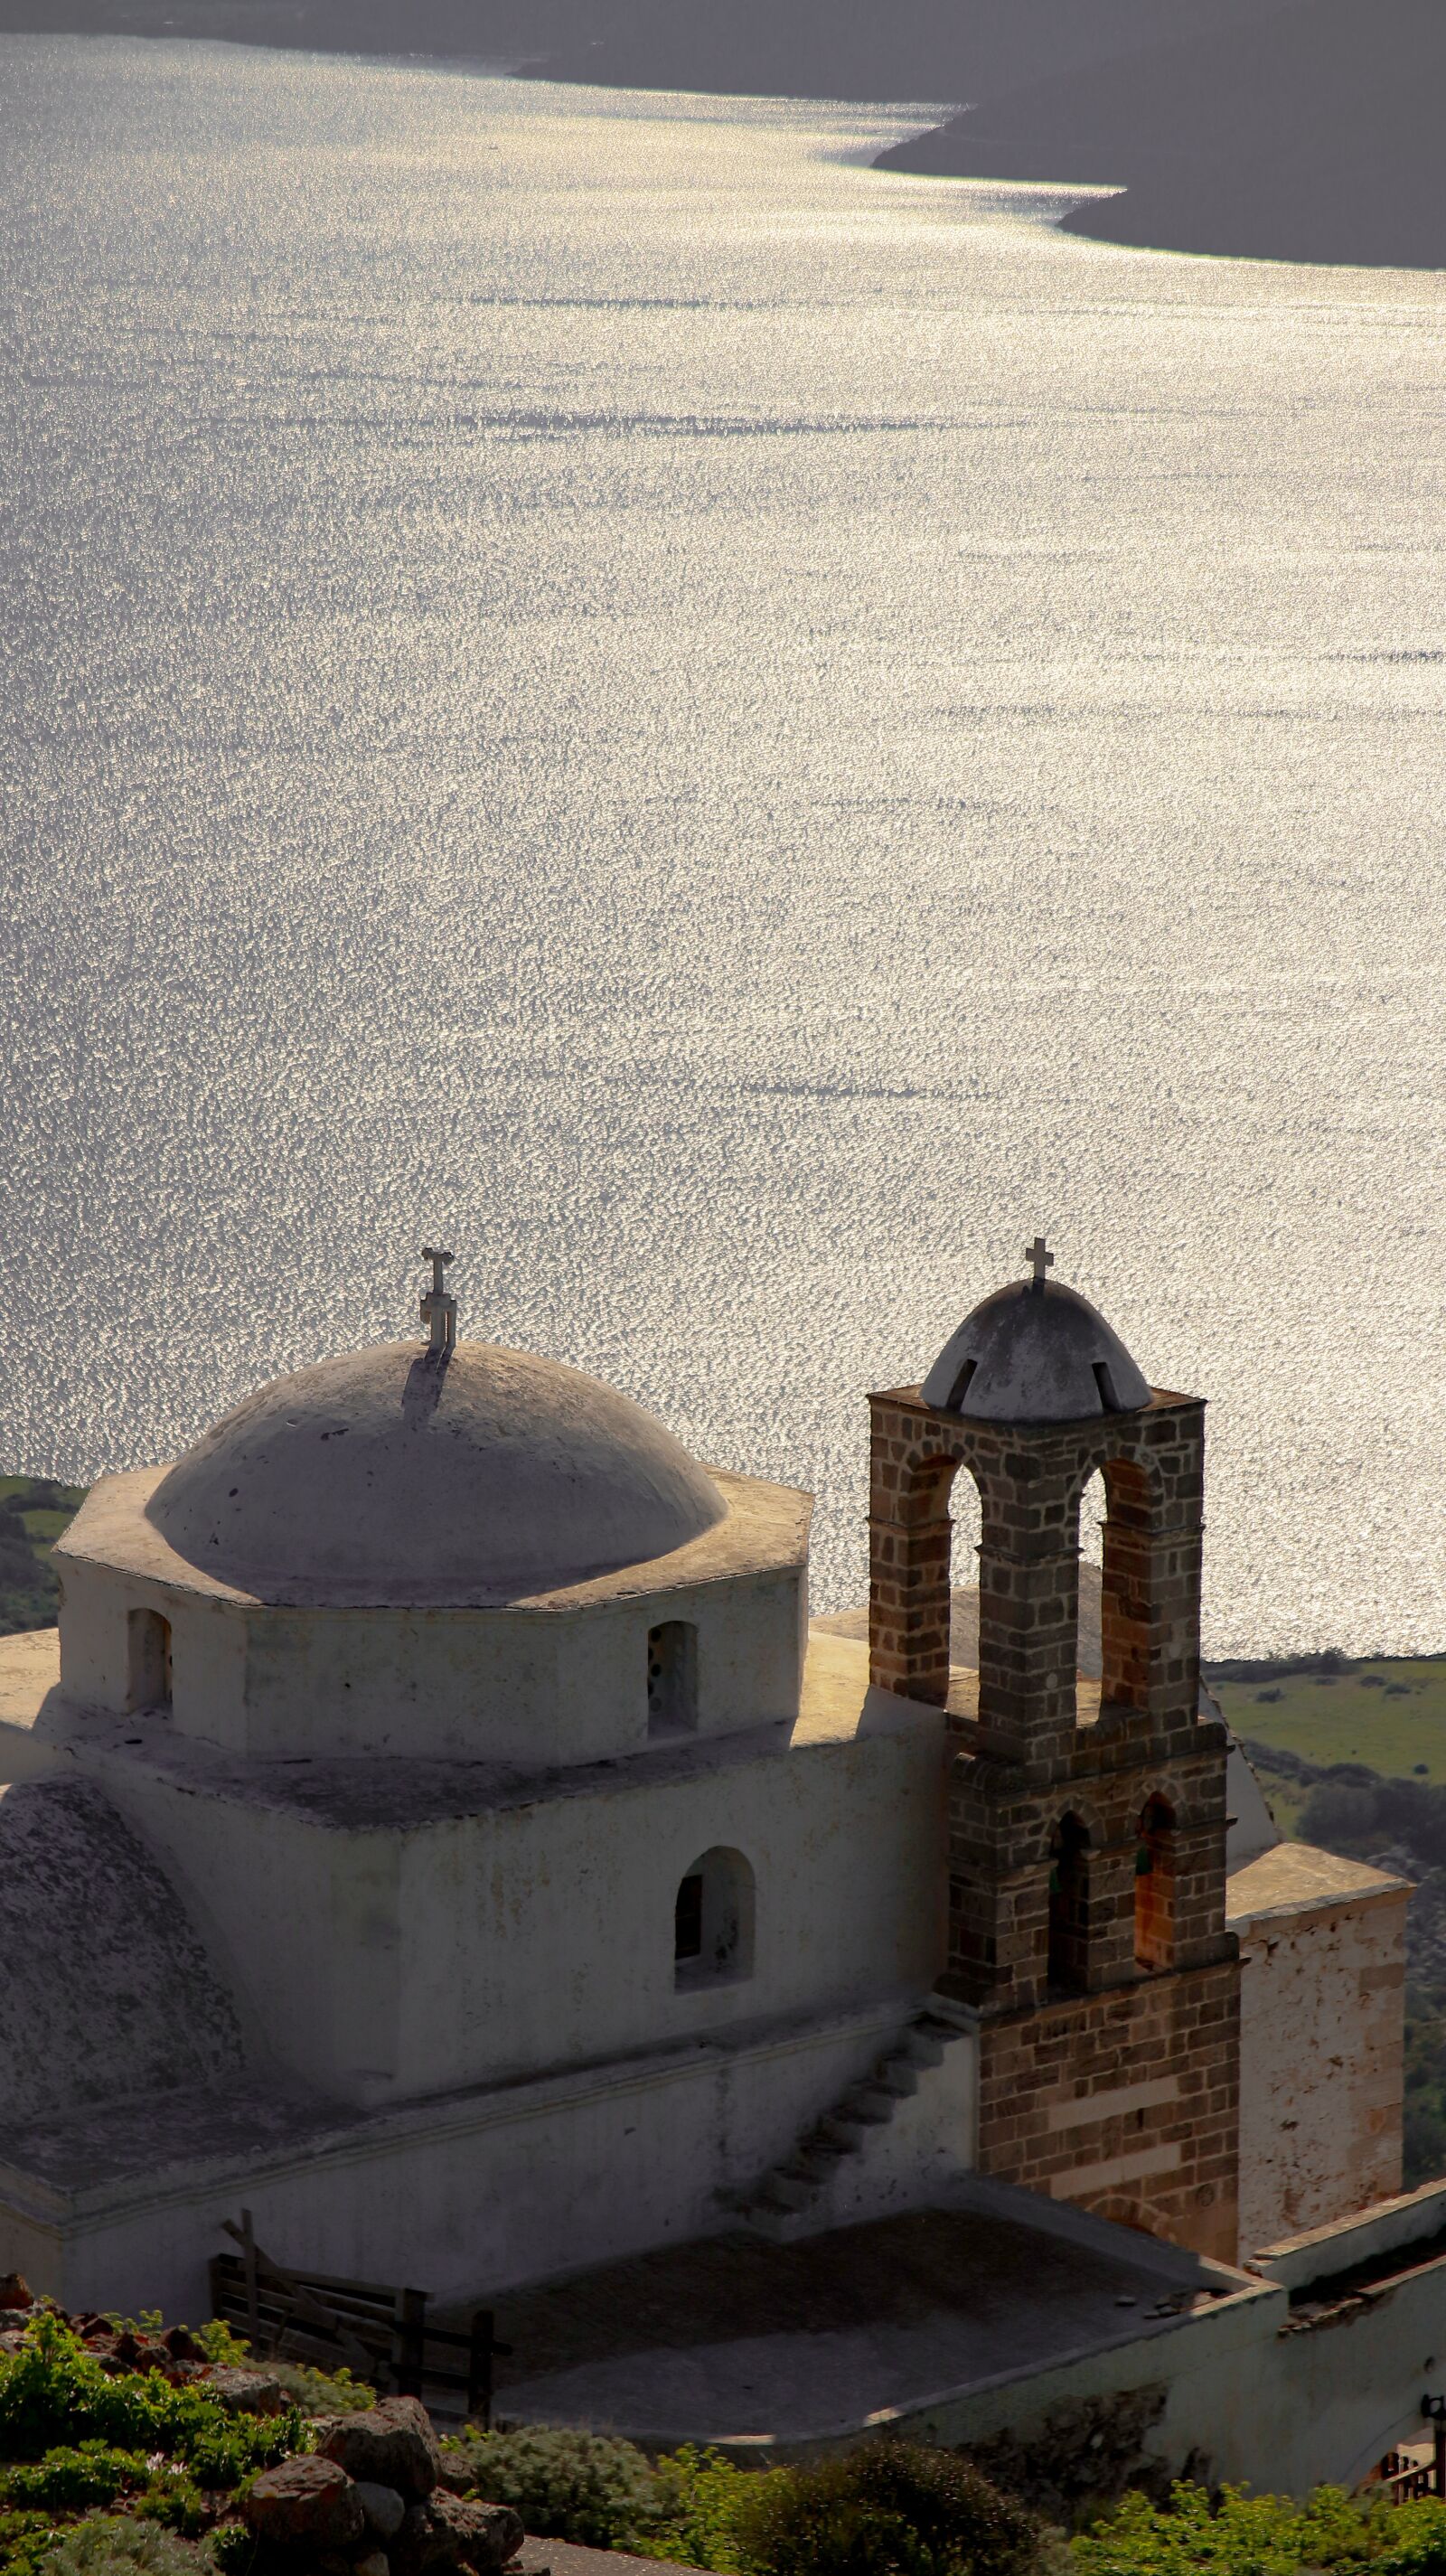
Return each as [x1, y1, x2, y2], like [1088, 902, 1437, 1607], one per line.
[147, 1342, 727, 1607]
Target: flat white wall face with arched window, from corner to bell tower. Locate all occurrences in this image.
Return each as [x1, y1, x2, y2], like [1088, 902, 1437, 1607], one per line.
[389, 1726, 946, 2092]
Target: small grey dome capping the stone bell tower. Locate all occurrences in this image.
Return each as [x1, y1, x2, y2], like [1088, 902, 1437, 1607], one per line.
[923, 1278, 1150, 1422]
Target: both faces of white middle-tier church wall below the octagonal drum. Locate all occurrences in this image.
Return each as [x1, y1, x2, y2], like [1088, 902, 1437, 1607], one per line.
[90, 1708, 946, 2104]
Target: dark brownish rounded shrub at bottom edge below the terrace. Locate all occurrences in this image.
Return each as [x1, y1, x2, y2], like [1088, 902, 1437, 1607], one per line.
[735, 2442, 1041, 2576]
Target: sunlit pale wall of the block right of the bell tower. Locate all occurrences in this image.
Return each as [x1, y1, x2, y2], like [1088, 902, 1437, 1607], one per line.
[1237, 1894, 1407, 2252]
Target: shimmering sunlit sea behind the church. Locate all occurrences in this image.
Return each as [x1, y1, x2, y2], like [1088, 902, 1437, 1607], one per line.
[0, 39, 1446, 1651]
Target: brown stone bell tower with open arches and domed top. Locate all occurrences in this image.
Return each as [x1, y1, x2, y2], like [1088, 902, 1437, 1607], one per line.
[869, 1242, 1240, 2261]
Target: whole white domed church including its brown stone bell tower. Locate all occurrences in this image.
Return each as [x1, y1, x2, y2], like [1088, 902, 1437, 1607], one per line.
[0, 1245, 1446, 2483]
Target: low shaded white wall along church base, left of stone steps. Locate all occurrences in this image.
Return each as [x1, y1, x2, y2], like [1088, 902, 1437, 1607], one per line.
[0, 2009, 974, 2318]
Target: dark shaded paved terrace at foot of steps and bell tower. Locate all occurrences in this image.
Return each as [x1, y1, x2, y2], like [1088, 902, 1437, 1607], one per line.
[482, 2182, 1250, 2449]
